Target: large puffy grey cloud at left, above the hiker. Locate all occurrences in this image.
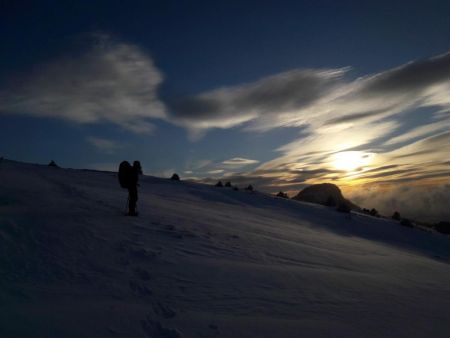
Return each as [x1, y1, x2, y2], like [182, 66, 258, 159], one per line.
[0, 34, 166, 133]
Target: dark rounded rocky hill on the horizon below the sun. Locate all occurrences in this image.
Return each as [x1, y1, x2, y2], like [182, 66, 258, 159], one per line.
[292, 183, 361, 210]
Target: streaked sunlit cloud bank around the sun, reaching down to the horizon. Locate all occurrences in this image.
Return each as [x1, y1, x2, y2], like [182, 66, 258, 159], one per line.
[184, 53, 450, 217]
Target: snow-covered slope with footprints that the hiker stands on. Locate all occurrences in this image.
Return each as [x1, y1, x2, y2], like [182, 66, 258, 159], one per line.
[0, 160, 450, 338]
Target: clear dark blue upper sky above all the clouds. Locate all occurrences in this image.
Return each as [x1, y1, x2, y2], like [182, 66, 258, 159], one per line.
[0, 1, 450, 84]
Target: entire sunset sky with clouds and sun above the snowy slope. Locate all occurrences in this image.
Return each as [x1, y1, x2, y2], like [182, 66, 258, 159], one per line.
[0, 1, 450, 221]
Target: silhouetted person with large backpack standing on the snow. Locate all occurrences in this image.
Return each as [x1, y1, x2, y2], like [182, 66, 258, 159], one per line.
[119, 161, 142, 216]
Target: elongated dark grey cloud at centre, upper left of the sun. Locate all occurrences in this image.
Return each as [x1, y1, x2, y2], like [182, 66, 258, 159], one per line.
[167, 69, 347, 132]
